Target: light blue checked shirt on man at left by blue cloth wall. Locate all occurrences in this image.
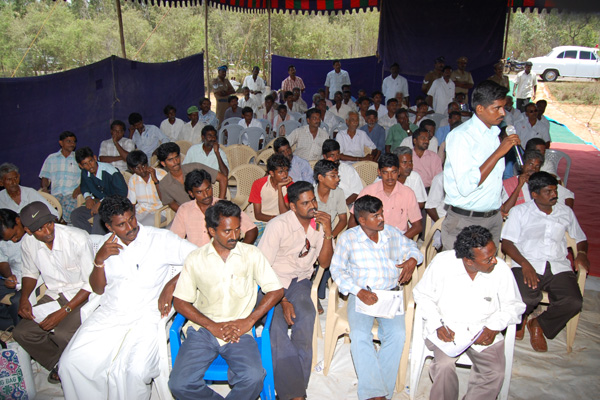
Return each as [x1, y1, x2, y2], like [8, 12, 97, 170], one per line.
[40, 150, 81, 195]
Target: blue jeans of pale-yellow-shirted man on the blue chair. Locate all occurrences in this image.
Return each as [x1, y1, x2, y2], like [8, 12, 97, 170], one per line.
[169, 328, 266, 400]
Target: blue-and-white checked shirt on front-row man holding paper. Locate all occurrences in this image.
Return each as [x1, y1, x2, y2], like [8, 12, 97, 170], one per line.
[330, 225, 423, 295]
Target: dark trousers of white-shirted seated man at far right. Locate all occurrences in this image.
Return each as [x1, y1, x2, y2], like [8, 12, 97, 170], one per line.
[512, 263, 583, 339]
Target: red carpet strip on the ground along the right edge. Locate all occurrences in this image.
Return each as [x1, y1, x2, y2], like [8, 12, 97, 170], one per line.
[551, 142, 600, 276]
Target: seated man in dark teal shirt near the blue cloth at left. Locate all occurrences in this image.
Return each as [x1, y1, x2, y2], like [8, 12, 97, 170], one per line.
[71, 147, 127, 235]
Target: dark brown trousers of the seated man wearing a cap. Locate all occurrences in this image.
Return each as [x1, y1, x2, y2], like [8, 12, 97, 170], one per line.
[13, 296, 87, 370]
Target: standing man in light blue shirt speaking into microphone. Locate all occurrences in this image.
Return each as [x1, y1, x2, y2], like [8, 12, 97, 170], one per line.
[442, 81, 521, 250]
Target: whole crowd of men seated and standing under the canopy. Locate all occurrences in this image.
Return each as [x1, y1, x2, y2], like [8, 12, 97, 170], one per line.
[0, 57, 589, 400]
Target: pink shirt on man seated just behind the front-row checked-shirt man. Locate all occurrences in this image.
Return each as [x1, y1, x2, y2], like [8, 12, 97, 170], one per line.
[350, 181, 423, 233]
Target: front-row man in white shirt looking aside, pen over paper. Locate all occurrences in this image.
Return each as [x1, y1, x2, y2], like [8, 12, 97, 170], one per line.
[413, 225, 525, 399]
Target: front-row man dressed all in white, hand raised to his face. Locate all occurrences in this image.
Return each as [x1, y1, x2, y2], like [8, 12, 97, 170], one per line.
[59, 195, 196, 400]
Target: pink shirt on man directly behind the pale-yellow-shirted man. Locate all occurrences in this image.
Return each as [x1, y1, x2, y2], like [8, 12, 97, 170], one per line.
[171, 197, 256, 247]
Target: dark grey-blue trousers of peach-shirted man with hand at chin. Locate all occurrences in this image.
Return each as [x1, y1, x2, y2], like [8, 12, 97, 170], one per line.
[258, 278, 316, 400]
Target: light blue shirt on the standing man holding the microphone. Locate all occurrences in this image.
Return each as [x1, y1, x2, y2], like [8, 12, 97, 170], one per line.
[444, 116, 504, 212]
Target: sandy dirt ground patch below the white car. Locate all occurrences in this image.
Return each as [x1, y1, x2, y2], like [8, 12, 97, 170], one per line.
[536, 82, 600, 148]
